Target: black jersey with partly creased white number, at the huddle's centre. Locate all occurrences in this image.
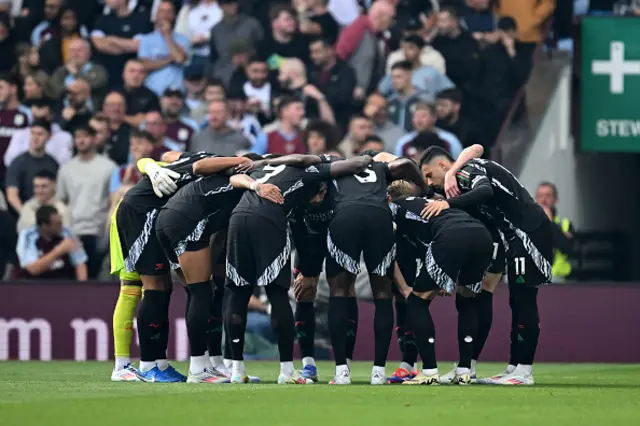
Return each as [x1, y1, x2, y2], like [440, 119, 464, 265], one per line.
[330, 162, 392, 211]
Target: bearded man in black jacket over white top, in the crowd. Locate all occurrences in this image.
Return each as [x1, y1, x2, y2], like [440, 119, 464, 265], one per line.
[242, 56, 275, 125]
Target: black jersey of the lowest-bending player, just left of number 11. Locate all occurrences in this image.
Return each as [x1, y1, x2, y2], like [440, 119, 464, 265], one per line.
[389, 197, 481, 257]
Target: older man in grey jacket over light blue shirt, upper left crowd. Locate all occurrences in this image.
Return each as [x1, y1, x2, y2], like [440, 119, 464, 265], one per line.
[51, 39, 109, 110]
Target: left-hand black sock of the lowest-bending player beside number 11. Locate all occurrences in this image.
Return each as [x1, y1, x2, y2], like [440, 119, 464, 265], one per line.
[407, 294, 438, 369]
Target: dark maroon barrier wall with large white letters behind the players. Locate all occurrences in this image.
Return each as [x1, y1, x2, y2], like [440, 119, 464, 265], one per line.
[0, 282, 640, 362]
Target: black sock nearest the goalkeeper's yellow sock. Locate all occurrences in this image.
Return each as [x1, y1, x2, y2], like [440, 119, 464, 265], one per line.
[138, 290, 166, 362]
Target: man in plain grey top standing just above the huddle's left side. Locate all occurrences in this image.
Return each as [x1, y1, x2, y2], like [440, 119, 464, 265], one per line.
[191, 100, 251, 157]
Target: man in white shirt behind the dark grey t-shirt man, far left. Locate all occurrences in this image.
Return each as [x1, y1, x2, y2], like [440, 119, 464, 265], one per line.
[4, 98, 73, 167]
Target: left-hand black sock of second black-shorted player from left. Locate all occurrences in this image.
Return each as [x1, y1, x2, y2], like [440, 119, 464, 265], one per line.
[187, 281, 213, 356]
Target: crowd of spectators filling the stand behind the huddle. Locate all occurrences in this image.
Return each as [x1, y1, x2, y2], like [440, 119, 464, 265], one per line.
[0, 0, 555, 280]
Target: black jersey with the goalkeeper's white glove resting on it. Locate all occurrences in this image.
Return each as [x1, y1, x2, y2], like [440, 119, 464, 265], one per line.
[122, 152, 219, 213]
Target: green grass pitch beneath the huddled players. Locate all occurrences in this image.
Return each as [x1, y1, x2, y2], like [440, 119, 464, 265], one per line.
[0, 362, 640, 426]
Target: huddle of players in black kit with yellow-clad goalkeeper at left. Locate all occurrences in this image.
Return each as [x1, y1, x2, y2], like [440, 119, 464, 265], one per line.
[111, 145, 552, 385]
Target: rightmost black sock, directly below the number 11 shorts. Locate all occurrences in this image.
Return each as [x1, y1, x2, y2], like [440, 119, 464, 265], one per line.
[514, 287, 540, 365]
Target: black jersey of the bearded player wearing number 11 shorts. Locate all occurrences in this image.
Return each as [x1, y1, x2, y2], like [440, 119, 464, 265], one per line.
[456, 159, 547, 234]
